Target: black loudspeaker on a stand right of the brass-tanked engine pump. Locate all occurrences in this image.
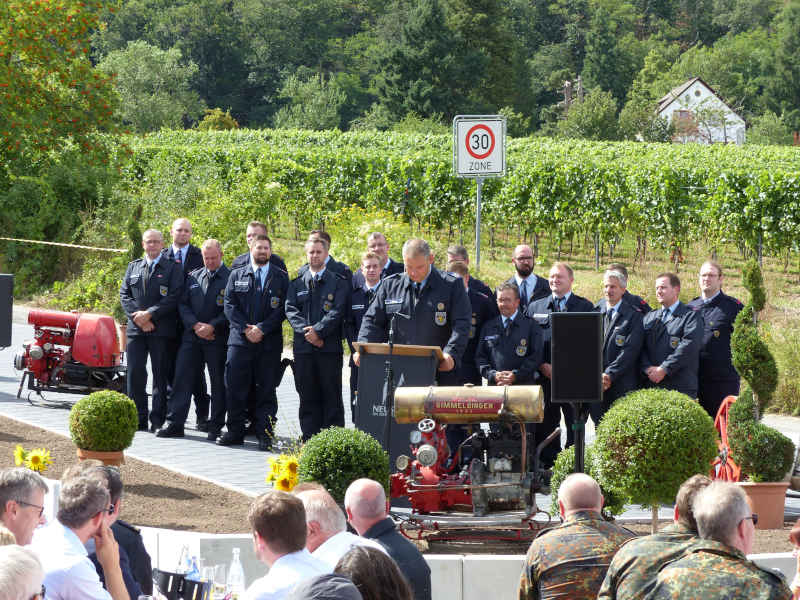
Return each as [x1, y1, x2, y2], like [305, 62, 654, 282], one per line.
[550, 312, 603, 404]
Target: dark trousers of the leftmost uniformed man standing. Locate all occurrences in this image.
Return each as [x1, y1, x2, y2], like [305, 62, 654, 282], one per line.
[126, 335, 167, 427]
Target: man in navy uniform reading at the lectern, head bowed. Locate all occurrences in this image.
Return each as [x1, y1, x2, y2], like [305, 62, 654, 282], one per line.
[353, 238, 472, 385]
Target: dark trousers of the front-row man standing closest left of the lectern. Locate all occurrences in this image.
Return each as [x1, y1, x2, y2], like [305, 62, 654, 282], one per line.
[294, 352, 344, 441]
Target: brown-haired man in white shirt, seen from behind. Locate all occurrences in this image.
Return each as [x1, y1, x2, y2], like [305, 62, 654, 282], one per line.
[245, 491, 333, 600]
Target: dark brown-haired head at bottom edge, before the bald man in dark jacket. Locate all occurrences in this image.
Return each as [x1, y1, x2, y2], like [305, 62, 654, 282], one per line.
[333, 546, 414, 600]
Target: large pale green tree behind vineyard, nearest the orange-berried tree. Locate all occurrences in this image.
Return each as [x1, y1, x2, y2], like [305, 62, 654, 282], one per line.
[97, 41, 205, 132]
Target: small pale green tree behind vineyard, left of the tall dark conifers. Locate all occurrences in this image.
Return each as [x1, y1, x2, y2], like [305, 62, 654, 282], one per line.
[275, 74, 345, 129]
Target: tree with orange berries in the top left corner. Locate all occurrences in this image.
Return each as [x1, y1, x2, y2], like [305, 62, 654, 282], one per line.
[0, 0, 117, 171]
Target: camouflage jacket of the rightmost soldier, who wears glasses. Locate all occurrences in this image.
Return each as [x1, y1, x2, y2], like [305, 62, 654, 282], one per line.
[647, 540, 792, 600]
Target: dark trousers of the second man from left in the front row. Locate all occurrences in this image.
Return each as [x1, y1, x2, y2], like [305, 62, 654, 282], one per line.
[167, 340, 225, 431]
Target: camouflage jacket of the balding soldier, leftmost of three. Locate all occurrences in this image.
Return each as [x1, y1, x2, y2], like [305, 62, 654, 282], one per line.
[519, 511, 633, 600]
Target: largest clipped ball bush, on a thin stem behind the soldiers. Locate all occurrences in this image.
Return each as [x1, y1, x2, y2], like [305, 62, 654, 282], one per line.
[594, 389, 717, 507]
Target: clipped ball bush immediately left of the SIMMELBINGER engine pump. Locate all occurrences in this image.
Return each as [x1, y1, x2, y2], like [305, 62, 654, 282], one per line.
[297, 427, 389, 504]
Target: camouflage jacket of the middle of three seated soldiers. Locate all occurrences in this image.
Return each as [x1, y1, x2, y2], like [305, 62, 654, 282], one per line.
[597, 523, 697, 600]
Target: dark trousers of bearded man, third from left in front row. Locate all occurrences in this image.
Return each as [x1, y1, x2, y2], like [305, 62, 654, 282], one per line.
[225, 344, 281, 437]
